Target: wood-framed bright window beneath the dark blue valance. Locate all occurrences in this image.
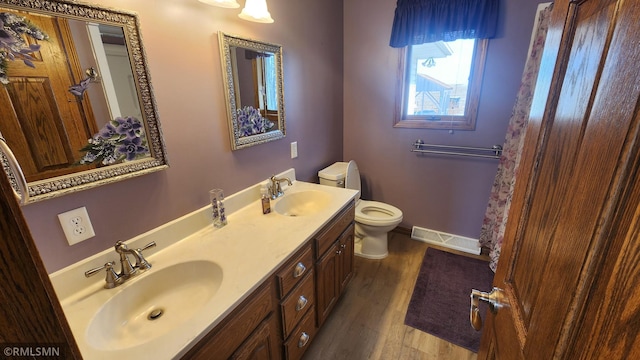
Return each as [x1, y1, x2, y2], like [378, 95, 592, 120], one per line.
[394, 39, 488, 130]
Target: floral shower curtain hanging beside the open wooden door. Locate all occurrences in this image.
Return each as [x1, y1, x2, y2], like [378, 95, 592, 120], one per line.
[480, 4, 552, 272]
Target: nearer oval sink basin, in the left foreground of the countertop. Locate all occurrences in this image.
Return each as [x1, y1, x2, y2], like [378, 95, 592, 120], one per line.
[85, 261, 222, 350]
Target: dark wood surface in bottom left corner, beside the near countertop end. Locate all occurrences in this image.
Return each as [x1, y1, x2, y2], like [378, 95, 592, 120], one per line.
[0, 148, 82, 359]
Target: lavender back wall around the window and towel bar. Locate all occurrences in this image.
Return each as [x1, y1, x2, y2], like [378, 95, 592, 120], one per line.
[343, 0, 538, 238]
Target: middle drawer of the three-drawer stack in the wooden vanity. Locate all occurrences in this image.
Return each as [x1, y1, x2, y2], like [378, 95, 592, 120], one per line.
[280, 270, 315, 338]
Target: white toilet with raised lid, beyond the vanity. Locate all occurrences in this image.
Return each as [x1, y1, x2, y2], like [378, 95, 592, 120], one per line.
[318, 160, 402, 259]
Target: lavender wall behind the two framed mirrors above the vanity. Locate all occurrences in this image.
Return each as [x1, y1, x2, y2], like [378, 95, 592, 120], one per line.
[23, 0, 343, 272]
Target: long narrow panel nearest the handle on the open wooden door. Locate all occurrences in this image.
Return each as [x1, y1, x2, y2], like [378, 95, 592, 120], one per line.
[512, 2, 612, 327]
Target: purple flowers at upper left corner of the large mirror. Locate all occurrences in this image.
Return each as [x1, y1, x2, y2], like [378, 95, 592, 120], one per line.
[0, 12, 49, 85]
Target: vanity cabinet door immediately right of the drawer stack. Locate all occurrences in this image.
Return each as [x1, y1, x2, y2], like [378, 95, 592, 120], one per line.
[316, 242, 340, 327]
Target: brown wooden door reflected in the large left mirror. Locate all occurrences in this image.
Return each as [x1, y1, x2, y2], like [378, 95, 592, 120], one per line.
[0, 12, 98, 182]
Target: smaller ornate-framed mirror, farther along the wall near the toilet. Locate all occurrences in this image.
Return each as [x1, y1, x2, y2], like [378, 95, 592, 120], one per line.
[218, 32, 286, 150]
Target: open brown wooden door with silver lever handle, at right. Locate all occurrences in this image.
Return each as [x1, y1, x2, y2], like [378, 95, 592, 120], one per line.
[478, 0, 640, 359]
